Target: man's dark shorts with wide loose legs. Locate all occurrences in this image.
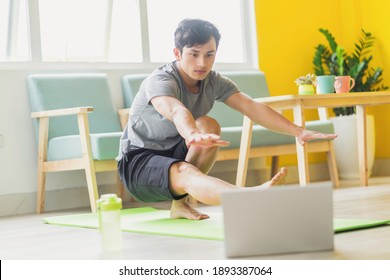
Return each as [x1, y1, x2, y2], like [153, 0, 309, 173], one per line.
[118, 139, 188, 202]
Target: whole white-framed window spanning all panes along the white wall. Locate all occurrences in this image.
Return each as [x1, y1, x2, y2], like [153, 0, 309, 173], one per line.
[0, 0, 257, 69]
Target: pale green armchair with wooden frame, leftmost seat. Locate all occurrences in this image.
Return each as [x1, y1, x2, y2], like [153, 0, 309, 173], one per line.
[27, 74, 123, 213]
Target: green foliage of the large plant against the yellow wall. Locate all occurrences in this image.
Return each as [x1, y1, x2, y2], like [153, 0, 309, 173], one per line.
[313, 28, 388, 116]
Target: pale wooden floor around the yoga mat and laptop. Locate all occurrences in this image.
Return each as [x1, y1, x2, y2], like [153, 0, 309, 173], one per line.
[0, 178, 390, 260]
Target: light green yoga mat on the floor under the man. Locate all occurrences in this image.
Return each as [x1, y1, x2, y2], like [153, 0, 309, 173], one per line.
[43, 207, 390, 240]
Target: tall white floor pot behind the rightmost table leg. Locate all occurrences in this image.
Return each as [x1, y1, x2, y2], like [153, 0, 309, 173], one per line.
[331, 115, 375, 180]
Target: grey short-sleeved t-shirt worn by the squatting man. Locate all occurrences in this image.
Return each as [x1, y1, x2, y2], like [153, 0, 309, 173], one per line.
[117, 62, 239, 160]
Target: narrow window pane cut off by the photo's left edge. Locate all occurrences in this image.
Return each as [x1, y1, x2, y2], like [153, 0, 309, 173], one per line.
[0, 0, 30, 61]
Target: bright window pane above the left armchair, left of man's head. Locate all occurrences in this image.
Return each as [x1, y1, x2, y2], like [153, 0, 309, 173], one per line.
[39, 0, 142, 62]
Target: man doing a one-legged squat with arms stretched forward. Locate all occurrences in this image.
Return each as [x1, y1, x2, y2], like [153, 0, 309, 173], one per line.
[118, 19, 336, 219]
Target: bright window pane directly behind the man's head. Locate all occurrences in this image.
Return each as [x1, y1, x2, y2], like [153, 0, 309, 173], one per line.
[147, 0, 244, 63]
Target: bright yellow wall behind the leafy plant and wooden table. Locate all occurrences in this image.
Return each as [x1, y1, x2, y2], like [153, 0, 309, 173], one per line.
[255, 0, 390, 164]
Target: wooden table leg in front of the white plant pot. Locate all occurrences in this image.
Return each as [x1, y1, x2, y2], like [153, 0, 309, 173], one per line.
[356, 105, 368, 186]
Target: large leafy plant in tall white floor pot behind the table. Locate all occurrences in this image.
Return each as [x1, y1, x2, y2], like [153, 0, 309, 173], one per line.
[313, 28, 388, 179]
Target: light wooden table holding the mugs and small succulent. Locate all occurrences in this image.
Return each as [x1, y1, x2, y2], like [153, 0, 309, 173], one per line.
[237, 91, 390, 186]
